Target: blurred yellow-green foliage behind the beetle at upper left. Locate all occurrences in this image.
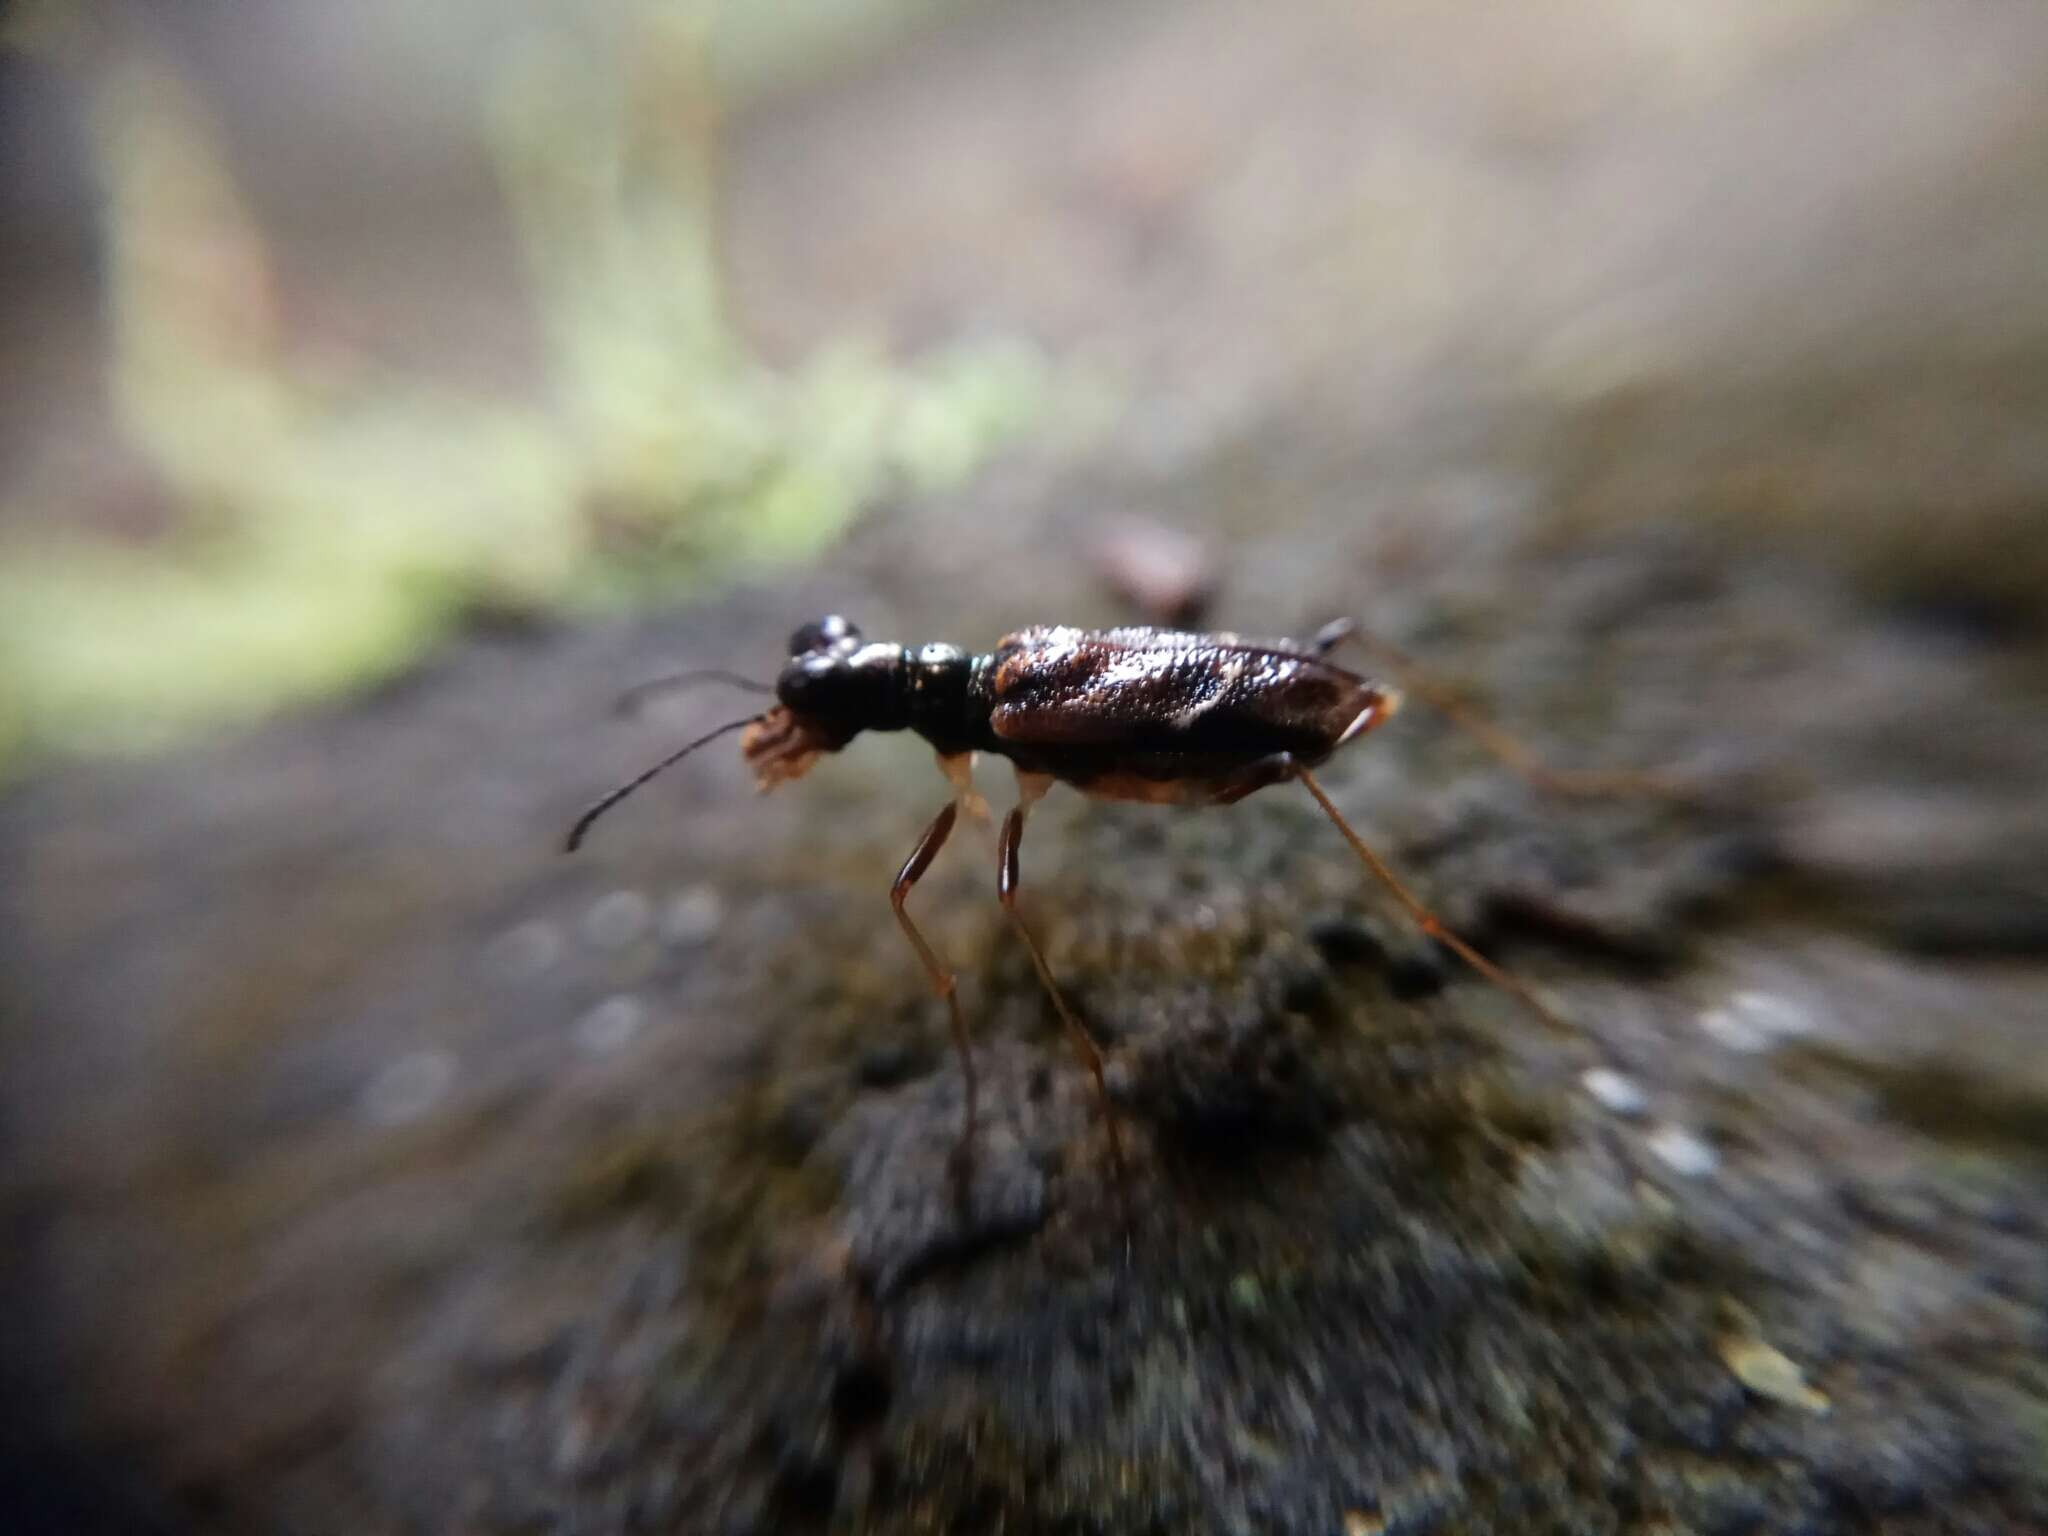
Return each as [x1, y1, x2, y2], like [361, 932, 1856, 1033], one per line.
[0, 0, 1047, 766]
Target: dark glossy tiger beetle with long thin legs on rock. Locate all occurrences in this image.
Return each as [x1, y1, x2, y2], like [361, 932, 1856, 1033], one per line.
[567, 616, 1665, 1184]
